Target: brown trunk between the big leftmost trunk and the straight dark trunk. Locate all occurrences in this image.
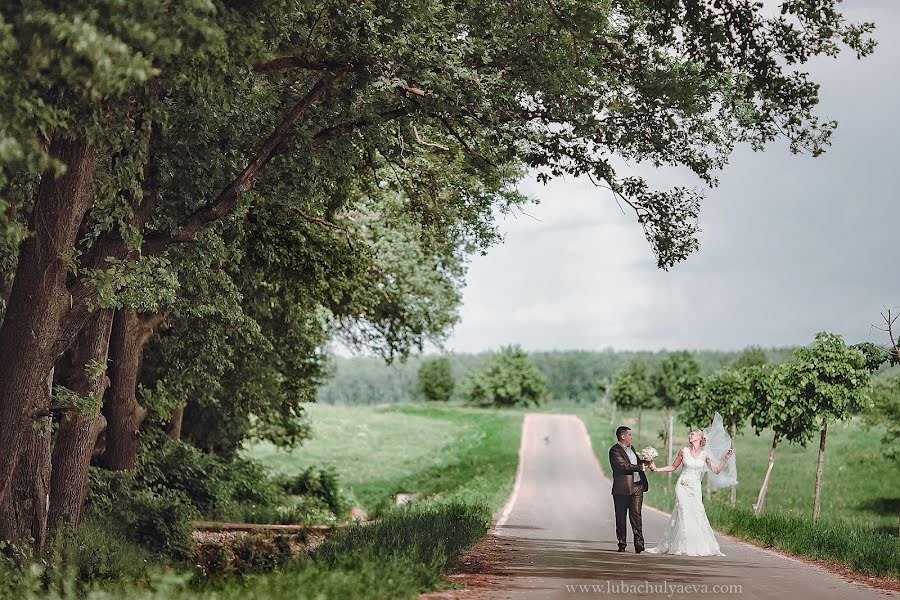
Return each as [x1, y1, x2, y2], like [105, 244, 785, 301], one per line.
[48, 308, 115, 531]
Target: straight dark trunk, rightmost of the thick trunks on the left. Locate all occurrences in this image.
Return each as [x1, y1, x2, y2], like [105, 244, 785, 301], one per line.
[102, 309, 163, 469]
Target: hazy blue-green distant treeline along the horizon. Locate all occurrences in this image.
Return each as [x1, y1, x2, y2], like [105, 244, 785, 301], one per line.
[318, 348, 794, 404]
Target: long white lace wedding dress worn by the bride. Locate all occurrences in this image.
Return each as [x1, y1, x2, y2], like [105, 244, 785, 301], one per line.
[647, 447, 725, 556]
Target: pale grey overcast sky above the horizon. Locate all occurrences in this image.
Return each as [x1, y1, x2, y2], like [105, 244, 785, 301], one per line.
[432, 0, 900, 352]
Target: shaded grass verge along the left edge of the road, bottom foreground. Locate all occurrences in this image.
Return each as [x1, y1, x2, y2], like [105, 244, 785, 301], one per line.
[44, 503, 490, 600]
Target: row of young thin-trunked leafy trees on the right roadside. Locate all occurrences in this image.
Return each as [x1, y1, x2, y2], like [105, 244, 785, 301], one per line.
[601, 332, 891, 519]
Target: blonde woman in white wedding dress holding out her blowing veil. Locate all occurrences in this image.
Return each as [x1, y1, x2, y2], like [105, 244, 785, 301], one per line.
[647, 413, 737, 556]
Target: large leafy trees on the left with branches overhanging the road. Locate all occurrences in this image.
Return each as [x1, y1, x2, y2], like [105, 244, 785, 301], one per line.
[0, 0, 874, 545]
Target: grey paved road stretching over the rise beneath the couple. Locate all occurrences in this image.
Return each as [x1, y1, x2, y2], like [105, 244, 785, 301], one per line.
[422, 414, 897, 600]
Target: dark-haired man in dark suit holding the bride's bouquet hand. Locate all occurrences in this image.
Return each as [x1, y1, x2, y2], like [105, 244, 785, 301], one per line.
[609, 425, 650, 554]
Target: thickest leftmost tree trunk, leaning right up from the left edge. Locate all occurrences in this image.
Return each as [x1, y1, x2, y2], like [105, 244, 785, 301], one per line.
[0, 140, 95, 502]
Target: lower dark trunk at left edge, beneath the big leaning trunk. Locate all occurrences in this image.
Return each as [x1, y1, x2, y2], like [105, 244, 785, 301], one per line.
[0, 370, 53, 551]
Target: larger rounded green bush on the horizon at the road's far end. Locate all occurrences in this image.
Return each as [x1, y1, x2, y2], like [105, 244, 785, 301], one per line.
[462, 345, 548, 406]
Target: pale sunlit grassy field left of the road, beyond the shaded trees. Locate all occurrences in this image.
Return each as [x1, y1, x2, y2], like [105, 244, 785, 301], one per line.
[245, 404, 524, 517]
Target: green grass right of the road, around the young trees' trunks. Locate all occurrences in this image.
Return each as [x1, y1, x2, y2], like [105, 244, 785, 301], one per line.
[573, 407, 900, 577]
